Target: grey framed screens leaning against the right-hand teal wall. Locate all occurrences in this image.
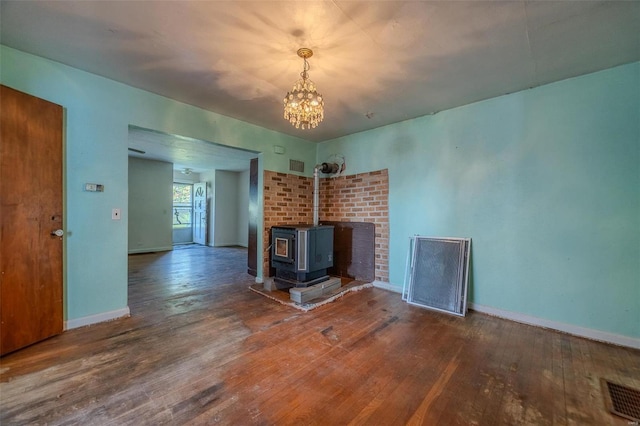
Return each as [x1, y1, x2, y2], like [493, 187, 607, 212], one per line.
[406, 237, 470, 315]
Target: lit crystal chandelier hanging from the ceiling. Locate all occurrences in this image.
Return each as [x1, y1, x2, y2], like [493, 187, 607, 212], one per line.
[284, 47, 324, 129]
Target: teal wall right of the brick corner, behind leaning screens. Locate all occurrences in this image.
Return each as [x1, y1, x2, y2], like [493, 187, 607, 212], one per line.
[318, 63, 640, 338]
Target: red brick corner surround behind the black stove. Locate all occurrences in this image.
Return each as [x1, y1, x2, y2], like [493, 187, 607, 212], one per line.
[263, 169, 389, 282]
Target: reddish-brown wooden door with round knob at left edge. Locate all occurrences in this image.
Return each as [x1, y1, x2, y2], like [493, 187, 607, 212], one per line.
[0, 86, 63, 355]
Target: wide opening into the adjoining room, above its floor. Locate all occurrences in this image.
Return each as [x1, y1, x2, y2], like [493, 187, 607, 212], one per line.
[128, 125, 262, 274]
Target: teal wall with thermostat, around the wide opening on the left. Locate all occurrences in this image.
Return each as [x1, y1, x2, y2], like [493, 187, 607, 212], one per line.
[0, 46, 316, 321]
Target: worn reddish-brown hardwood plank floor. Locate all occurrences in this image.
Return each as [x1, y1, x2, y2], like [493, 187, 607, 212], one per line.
[0, 246, 640, 425]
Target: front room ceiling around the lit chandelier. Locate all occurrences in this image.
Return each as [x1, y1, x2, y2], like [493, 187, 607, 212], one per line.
[0, 0, 640, 169]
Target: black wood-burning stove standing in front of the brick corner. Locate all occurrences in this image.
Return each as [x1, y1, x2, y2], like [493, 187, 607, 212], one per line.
[271, 225, 333, 289]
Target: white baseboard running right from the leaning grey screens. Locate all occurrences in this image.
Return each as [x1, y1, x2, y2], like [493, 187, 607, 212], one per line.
[469, 303, 640, 349]
